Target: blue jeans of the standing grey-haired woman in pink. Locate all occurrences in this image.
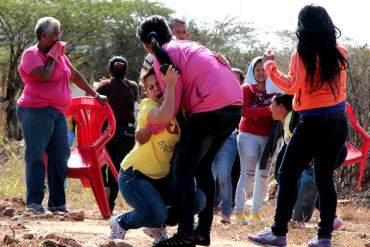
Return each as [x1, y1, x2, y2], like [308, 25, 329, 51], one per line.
[17, 106, 70, 210]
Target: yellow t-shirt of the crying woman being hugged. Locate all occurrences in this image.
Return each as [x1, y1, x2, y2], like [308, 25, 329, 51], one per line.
[121, 98, 180, 179]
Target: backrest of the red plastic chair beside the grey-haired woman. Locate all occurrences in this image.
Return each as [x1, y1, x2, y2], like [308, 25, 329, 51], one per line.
[66, 96, 116, 150]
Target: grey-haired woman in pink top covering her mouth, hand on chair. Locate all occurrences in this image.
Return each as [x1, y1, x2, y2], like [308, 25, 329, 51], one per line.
[17, 17, 106, 213]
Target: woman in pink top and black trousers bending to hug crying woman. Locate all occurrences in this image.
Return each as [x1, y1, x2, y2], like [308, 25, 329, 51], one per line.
[137, 16, 243, 246]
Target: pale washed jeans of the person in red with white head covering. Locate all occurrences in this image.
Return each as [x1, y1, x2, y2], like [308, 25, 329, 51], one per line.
[235, 132, 271, 214]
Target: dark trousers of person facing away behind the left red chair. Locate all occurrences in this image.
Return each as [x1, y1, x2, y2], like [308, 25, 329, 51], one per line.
[103, 124, 135, 212]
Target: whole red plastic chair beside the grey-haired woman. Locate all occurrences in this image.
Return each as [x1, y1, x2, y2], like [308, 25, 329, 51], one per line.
[66, 97, 118, 218]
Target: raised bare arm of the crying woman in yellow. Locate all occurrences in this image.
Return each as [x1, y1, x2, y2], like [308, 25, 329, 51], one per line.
[148, 66, 179, 124]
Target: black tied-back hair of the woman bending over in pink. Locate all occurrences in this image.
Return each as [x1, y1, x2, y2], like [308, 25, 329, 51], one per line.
[137, 15, 173, 65]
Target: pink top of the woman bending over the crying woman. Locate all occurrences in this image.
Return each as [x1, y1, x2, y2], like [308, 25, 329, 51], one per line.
[153, 40, 243, 116]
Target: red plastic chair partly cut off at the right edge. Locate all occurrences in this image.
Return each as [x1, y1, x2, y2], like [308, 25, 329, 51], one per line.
[341, 103, 370, 191]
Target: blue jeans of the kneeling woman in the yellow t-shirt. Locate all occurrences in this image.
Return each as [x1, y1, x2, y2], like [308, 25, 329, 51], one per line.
[117, 168, 205, 230]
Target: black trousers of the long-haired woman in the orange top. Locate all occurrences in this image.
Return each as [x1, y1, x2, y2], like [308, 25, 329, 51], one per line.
[272, 112, 348, 238]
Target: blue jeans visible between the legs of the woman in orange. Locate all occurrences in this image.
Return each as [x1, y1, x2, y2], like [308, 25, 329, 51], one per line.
[293, 166, 318, 222]
